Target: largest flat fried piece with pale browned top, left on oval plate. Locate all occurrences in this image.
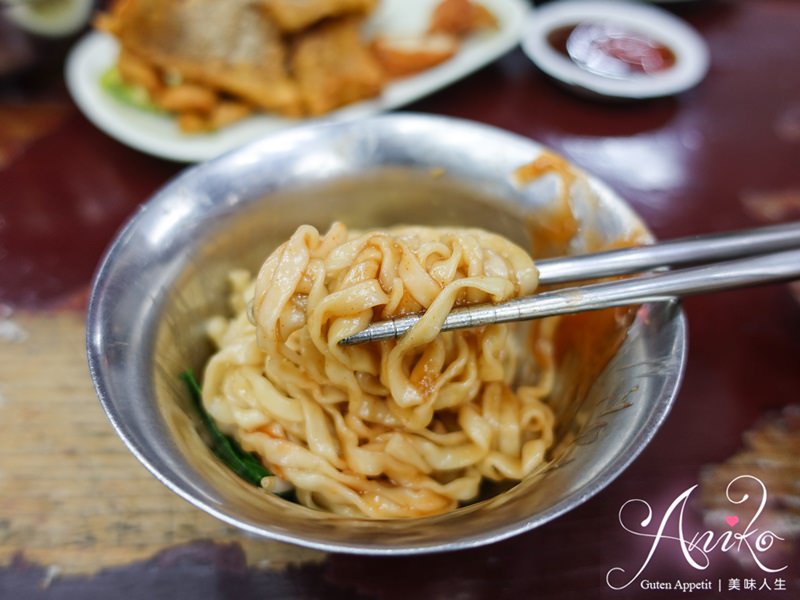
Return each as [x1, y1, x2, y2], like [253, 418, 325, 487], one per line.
[100, 0, 301, 115]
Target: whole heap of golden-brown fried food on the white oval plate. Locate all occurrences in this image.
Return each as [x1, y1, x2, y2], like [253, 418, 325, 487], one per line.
[95, 0, 496, 133]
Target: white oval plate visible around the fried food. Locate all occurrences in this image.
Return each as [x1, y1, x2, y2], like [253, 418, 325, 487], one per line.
[66, 0, 529, 162]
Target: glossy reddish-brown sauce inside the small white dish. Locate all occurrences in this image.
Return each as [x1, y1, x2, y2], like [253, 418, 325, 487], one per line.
[547, 21, 675, 78]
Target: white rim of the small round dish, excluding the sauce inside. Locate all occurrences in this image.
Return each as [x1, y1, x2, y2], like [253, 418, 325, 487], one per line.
[522, 0, 709, 98]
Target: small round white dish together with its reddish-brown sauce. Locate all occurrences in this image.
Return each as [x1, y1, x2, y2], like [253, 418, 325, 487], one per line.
[522, 0, 709, 99]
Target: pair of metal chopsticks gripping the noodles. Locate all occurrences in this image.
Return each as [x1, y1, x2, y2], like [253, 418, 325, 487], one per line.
[339, 222, 800, 345]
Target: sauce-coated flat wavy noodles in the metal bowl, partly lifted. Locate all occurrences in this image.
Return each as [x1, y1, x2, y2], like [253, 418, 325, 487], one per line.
[203, 223, 557, 518]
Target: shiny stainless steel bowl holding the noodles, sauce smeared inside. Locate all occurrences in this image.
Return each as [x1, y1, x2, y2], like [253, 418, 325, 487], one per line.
[87, 114, 686, 554]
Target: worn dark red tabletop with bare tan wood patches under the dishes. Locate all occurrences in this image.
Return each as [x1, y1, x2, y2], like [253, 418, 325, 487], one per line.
[0, 0, 800, 600]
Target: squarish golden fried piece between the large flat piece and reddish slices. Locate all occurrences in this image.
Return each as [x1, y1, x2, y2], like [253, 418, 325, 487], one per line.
[291, 17, 383, 115]
